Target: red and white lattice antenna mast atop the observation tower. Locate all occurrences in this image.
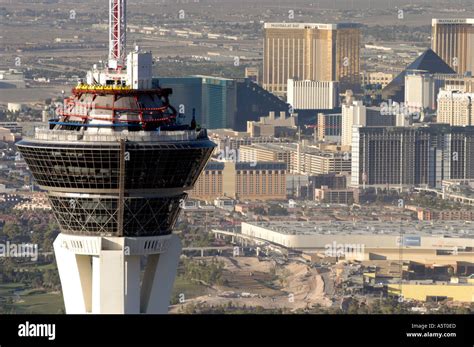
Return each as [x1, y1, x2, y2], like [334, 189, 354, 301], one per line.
[109, 0, 127, 70]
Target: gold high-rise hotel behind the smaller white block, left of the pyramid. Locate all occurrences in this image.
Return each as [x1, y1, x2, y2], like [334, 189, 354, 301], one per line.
[263, 23, 360, 96]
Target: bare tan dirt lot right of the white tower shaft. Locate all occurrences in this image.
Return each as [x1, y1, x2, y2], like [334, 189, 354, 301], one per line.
[170, 257, 331, 313]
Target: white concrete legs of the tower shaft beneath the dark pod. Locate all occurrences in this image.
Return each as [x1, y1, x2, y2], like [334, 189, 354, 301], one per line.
[54, 234, 181, 314]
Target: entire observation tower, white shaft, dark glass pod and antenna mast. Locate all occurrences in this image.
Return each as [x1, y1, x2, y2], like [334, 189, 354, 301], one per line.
[17, 0, 215, 314]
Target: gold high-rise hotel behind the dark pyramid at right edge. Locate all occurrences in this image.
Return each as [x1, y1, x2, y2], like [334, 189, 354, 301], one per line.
[431, 18, 474, 74]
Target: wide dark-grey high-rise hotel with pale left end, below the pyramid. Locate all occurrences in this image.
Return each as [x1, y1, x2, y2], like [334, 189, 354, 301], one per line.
[351, 123, 474, 189]
